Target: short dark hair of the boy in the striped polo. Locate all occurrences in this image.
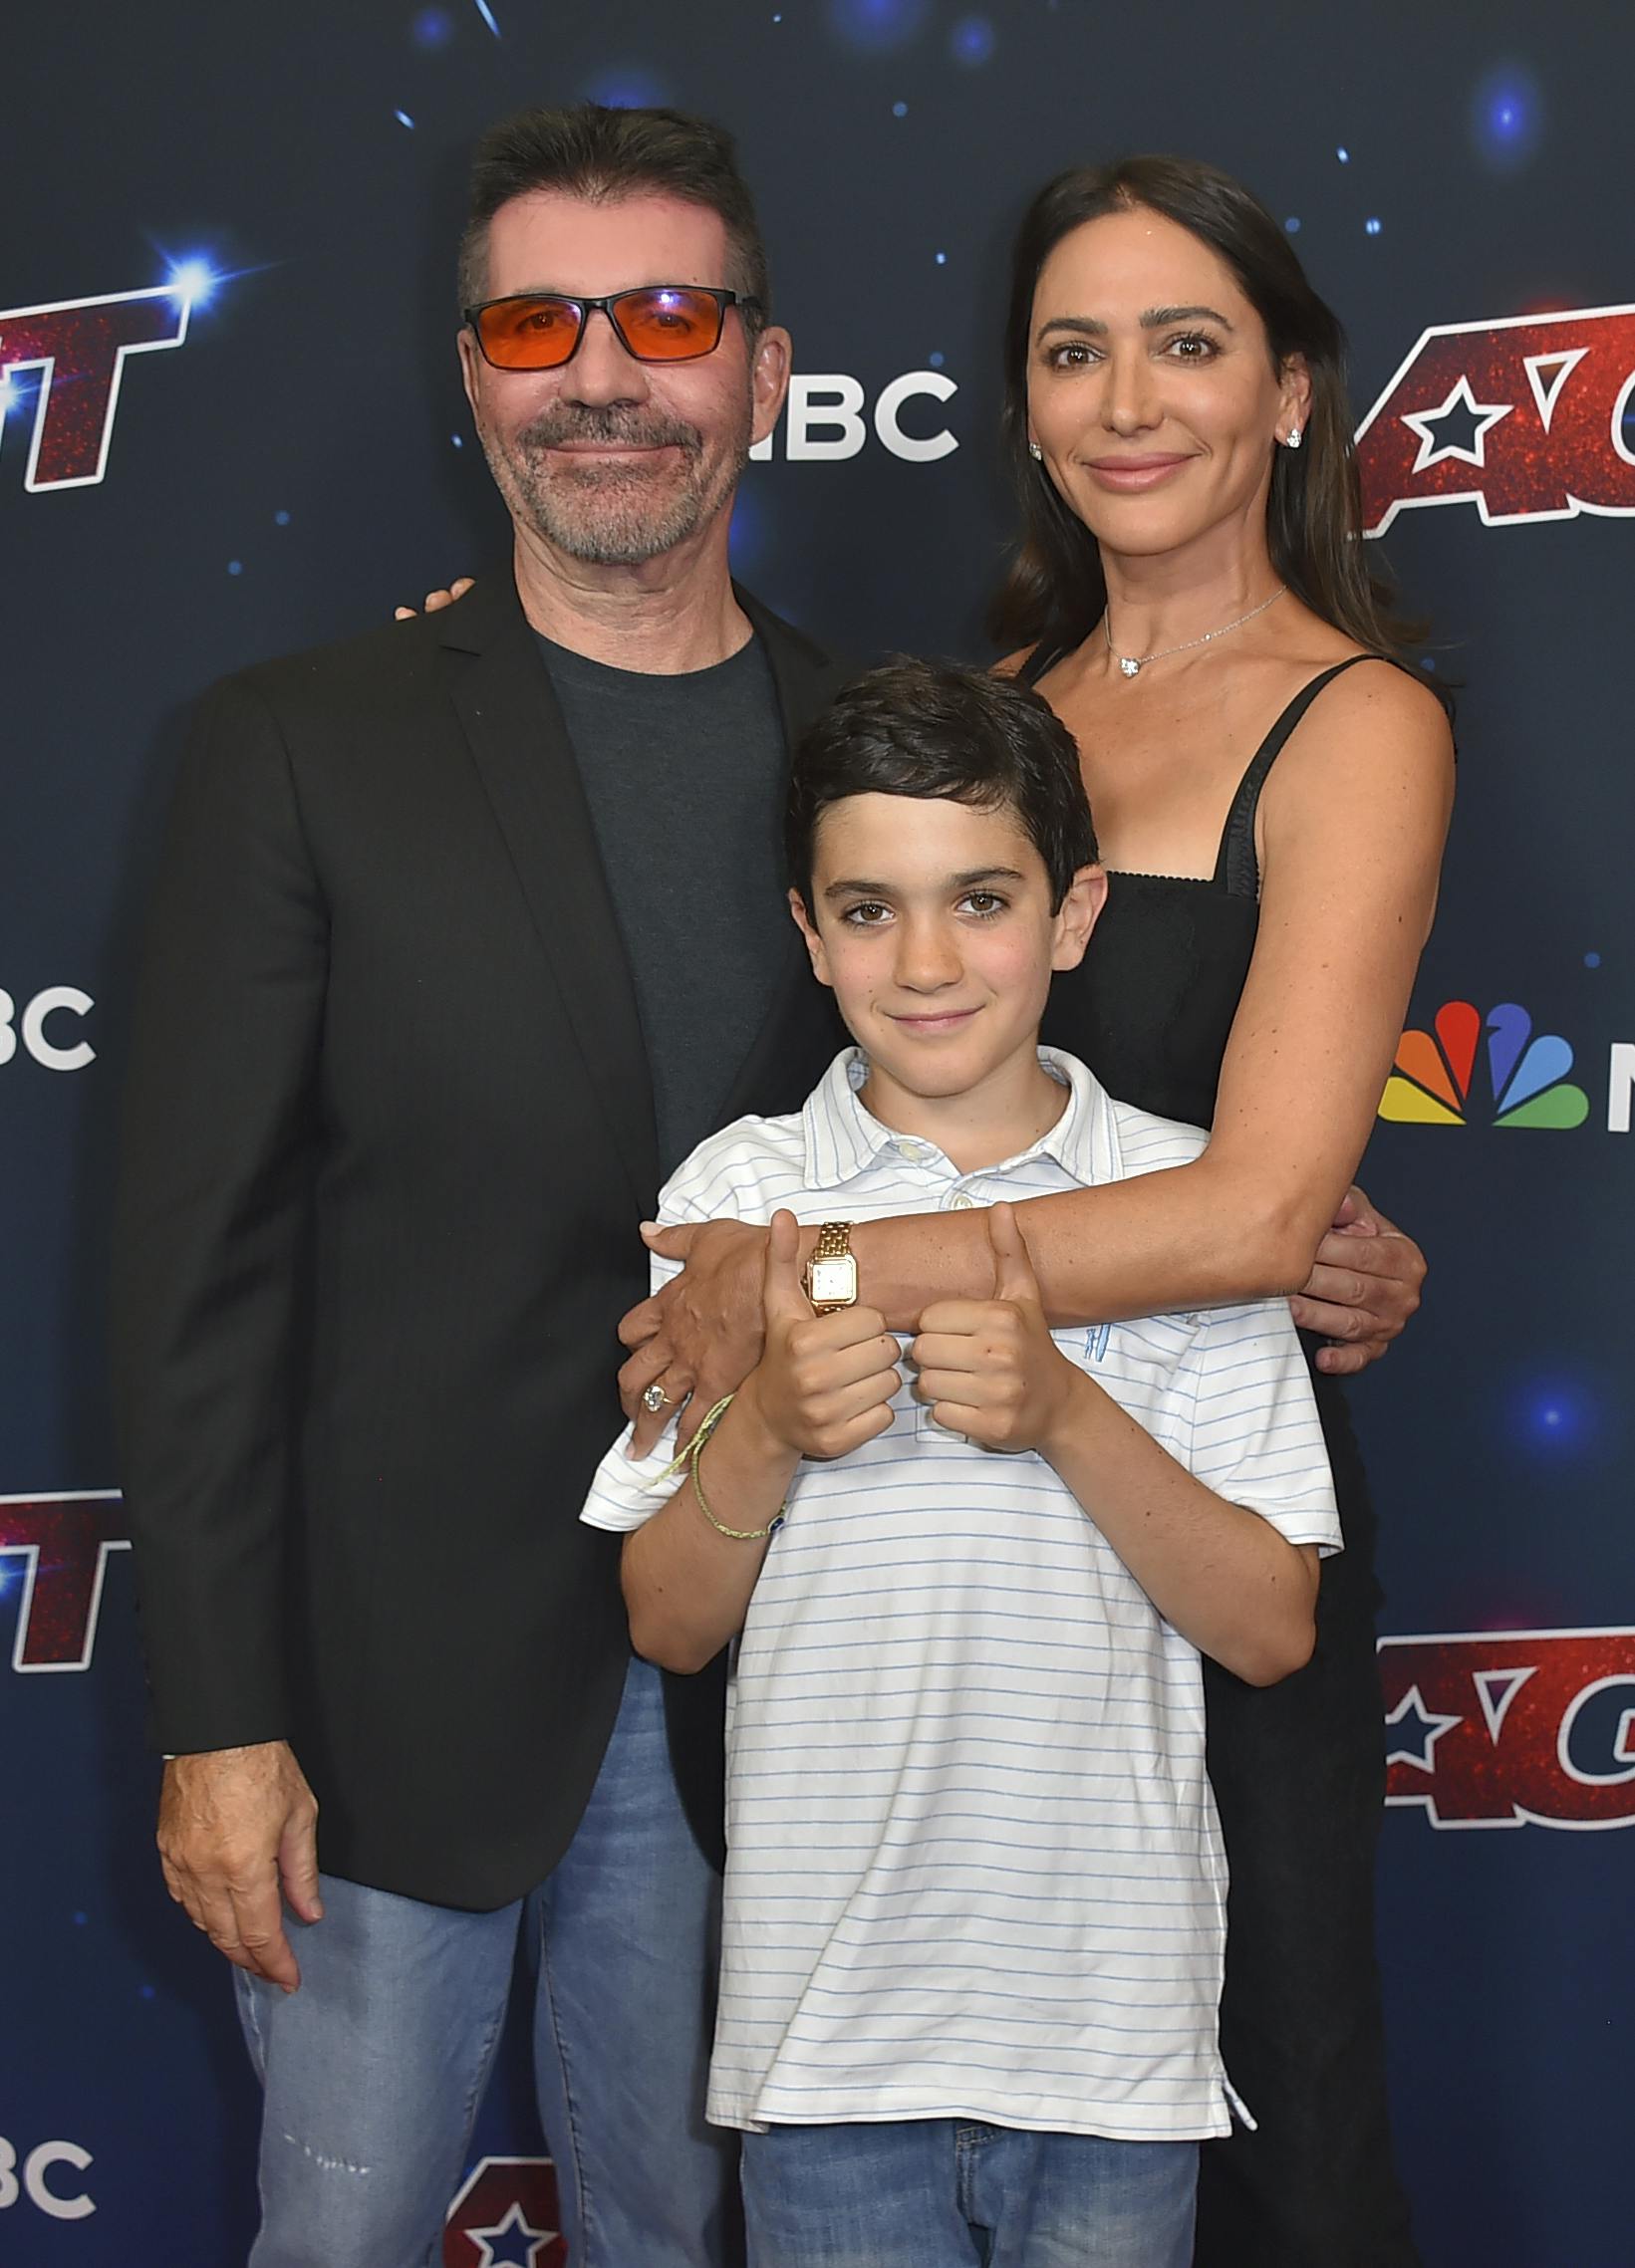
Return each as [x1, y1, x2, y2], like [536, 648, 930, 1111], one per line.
[784, 655, 1098, 911]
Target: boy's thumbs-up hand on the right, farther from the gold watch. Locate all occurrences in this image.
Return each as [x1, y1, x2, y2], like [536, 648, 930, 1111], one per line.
[910, 1204, 1079, 1449]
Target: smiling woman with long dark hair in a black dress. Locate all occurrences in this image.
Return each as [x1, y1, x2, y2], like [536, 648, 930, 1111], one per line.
[624, 158, 1454, 2268]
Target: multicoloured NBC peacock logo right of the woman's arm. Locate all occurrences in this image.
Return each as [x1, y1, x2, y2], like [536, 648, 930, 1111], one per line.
[1379, 1000, 1589, 1128]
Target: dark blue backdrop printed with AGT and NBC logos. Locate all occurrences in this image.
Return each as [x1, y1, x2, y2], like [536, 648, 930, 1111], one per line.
[0, 0, 1635, 2268]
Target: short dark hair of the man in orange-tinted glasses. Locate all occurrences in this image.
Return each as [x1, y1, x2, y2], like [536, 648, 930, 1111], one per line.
[460, 102, 771, 338]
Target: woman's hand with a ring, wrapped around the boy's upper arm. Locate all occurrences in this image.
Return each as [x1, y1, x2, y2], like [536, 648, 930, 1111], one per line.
[619, 1220, 766, 1456]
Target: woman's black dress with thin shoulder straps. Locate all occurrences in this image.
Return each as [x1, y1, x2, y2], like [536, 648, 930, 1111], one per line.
[1025, 655, 1418, 2268]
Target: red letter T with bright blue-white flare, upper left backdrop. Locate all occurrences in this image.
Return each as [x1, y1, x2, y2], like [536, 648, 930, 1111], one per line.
[0, 274, 213, 490]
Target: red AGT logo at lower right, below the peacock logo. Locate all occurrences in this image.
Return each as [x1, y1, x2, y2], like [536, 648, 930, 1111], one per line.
[1379, 1629, 1635, 1828]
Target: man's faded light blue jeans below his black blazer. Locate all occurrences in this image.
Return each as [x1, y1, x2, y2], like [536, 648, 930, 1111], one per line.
[238, 1660, 737, 2268]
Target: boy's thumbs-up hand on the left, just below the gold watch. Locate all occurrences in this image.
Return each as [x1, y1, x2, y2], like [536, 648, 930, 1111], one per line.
[739, 1211, 903, 1458]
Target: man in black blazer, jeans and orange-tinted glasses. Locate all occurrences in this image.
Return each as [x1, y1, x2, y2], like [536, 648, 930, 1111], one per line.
[116, 107, 844, 2268]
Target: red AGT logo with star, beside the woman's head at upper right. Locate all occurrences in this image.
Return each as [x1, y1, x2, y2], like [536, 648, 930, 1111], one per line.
[1356, 306, 1635, 535]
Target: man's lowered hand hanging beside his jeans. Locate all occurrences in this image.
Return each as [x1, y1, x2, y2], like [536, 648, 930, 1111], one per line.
[158, 1739, 324, 1991]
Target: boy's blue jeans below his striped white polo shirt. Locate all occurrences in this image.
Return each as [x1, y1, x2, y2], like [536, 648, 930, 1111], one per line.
[744, 2119, 1198, 2268]
